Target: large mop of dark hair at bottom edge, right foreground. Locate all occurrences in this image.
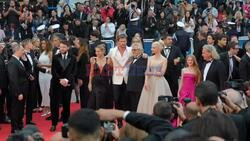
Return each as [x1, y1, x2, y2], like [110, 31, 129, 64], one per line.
[191, 109, 238, 141]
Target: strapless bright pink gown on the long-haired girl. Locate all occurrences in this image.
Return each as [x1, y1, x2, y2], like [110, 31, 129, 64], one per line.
[179, 73, 196, 105]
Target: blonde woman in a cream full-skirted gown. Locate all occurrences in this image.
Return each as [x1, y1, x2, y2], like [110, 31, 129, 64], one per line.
[137, 41, 172, 114]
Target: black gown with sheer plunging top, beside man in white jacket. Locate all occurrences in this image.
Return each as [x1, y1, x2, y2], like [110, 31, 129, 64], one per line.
[88, 58, 112, 110]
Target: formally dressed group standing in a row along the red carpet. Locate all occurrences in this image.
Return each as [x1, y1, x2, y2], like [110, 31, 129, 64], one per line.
[1, 27, 250, 132]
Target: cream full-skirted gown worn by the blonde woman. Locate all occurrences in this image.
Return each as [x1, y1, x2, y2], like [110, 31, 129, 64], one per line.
[137, 62, 172, 114]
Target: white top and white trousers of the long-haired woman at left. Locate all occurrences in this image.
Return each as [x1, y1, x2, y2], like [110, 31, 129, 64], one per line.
[39, 52, 52, 106]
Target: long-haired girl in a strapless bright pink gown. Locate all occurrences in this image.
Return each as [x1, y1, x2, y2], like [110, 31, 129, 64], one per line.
[178, 55, 201, 105]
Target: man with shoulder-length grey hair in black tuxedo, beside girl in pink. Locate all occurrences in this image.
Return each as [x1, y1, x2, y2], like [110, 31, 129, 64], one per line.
[202, 45, 227, 90]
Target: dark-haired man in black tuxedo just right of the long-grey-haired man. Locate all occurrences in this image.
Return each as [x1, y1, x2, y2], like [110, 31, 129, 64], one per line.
[220, 42, 240, 80]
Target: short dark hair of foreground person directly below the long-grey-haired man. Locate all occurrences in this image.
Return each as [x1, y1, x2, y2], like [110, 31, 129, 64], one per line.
[195, 81, 218, 106]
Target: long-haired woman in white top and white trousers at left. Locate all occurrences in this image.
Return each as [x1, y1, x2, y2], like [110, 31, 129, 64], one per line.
[38, 40, 52, 116]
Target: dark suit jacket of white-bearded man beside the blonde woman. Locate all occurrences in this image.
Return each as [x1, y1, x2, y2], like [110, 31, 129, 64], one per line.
[127, 57, 147, 92]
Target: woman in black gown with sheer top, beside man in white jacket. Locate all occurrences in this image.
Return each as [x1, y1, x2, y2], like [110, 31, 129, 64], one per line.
[88, 45, 112, 110]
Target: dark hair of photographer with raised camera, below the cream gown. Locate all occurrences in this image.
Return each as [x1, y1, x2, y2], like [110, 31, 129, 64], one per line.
[153, 101, 172, 120]
